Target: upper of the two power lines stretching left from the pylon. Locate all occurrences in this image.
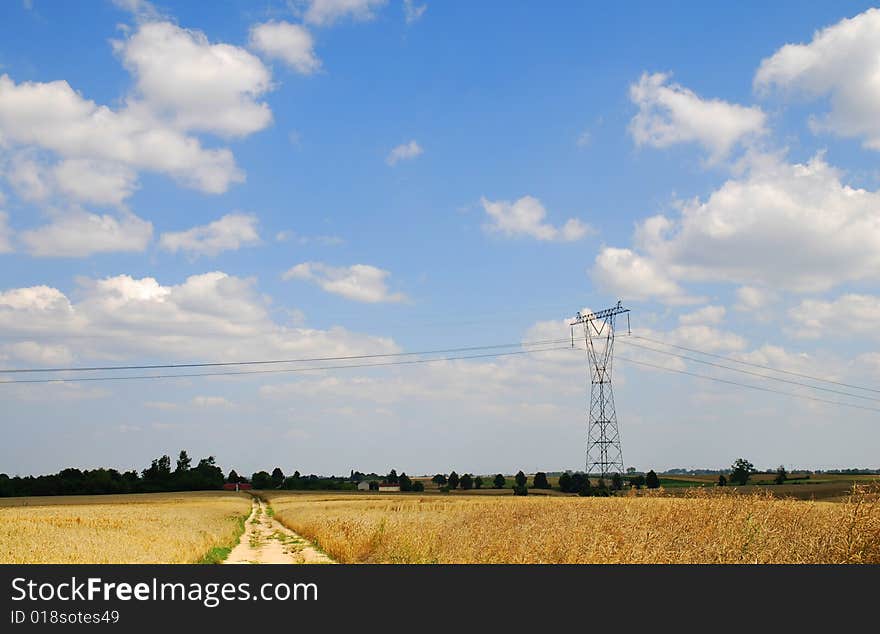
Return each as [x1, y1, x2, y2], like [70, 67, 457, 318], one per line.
[0, 339, 568, 376]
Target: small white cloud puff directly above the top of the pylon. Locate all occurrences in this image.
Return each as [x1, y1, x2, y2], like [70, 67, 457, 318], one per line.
[592, 247, 700, 304]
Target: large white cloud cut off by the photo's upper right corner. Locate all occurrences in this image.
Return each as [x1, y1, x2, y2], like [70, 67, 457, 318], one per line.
[754, 9, 880, 150]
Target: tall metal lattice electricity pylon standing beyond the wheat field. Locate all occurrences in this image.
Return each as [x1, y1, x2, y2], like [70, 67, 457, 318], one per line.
[570, 302, 629, 478]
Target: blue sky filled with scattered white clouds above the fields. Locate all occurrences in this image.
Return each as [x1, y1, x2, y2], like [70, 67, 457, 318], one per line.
[0, 0, 880, 473]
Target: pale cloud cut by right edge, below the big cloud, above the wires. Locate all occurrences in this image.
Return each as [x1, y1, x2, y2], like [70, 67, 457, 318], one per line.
[789, 293, 880, 339]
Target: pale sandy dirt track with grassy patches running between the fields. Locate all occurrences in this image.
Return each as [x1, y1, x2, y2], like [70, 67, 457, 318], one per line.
[223, 498, 334, 564]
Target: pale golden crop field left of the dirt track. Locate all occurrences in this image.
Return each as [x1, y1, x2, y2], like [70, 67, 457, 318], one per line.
[0, 491, 251, 564]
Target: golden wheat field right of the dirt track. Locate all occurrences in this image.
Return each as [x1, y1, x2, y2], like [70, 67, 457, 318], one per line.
[265, 487, 880, 563]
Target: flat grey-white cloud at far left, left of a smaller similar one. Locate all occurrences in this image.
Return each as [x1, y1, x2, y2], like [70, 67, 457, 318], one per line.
[20, 211, 153, 257]
